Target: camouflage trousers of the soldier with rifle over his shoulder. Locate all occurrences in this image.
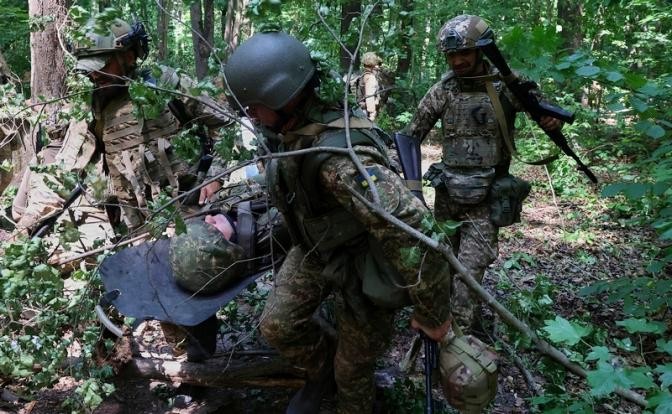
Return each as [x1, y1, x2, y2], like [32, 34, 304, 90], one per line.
[434, 187, 499, 330]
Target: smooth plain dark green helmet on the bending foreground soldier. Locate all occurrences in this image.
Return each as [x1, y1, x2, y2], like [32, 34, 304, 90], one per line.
[224, 32, 315, 110]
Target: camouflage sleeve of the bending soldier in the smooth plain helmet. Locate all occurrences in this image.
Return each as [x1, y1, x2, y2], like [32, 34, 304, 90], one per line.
[320, 150, 451, 327]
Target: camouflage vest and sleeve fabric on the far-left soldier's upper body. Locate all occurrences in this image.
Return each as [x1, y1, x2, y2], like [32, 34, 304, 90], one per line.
[93, 67, 231, 229]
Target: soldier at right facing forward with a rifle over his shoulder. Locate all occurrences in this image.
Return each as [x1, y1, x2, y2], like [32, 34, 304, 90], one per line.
[404, 15, 562, 328]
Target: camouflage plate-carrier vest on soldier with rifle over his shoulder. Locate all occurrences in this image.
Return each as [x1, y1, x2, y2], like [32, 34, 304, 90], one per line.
[442, 75, 515, 168]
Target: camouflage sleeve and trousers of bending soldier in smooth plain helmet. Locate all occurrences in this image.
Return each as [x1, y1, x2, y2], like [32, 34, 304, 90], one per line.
[261, 142, 451, 413]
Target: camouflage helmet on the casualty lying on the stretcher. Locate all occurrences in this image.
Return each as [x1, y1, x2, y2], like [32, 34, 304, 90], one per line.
[170, 218, 246, 294]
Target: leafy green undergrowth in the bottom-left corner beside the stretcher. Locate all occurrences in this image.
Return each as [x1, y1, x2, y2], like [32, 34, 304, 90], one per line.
[0, 239, 112, 409]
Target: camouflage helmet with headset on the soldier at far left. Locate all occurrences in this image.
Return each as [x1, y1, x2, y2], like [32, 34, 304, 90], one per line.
[74, 18, 149, 73]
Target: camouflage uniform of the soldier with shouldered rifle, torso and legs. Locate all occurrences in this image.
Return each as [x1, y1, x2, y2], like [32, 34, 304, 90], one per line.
[404, 62, 538, 330]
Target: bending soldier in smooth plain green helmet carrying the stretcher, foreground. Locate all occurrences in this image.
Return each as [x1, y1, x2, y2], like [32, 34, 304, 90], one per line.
[225, 32, 451, 413]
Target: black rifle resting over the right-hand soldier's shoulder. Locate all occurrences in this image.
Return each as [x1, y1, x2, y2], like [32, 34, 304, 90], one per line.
[476, 39, 597, 183]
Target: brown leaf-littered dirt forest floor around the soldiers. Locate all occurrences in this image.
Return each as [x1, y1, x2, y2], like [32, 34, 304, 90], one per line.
[0, 147, 654, 414]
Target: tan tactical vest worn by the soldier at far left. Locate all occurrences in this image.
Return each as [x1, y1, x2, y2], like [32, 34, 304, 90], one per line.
[95, 68, 189, 207]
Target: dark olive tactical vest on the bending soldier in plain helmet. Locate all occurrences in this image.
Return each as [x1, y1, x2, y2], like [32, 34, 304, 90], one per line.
[266, 118, 388, 257]
